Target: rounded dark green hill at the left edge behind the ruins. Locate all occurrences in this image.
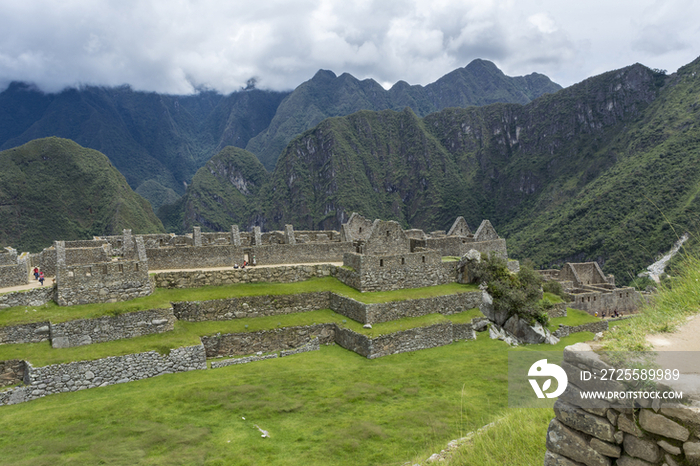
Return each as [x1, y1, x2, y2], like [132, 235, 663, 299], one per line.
[0, 137, 164, 252]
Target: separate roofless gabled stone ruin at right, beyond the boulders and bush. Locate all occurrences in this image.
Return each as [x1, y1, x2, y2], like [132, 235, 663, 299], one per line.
[540, 262, 644, 314]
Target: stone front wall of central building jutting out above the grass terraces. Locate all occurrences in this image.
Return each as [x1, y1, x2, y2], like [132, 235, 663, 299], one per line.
[336, 250, 457, 291]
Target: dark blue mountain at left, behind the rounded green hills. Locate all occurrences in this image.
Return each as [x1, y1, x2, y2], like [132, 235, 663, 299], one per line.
[0, 83, 288, 209]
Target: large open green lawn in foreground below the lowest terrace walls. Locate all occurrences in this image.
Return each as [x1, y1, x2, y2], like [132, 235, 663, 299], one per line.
[0, 333, 590, 466]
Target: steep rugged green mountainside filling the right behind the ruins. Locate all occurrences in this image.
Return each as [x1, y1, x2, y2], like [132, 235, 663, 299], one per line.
[170, 59, 700, 283]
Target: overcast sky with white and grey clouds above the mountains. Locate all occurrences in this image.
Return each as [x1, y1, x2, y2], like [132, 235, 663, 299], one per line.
[0, 0, 700, 94]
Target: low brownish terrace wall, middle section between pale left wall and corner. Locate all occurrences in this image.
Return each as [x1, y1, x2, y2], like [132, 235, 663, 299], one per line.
[202, 324, 335, 358]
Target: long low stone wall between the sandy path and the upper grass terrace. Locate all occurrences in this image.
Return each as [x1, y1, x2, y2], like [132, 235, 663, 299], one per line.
[155, 264, 335, 288]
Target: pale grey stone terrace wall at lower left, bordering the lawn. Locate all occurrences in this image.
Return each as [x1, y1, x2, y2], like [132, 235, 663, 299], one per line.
[0, 345, 207, 405]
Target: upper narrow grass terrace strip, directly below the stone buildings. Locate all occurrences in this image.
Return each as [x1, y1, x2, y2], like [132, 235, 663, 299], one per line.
[0, 277, 478, 327]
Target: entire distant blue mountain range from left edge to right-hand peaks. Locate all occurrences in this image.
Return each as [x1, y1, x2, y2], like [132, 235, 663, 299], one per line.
[0, 60, 560, 210]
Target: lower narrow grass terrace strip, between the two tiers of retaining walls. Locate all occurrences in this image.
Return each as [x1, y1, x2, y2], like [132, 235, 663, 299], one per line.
[0, 309, 482, 366]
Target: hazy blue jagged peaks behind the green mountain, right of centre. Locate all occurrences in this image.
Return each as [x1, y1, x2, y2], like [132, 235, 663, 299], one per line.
[246, 60, 561, 170]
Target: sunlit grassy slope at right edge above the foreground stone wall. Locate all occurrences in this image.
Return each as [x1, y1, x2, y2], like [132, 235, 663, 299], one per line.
[603, 256, 700, 351]
